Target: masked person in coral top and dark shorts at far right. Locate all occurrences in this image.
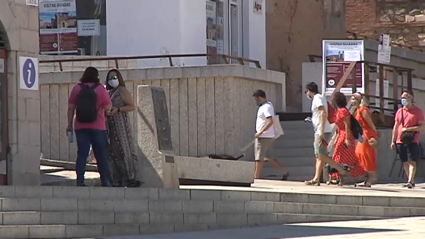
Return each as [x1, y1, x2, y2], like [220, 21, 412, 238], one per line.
[391, 91, 424, 188]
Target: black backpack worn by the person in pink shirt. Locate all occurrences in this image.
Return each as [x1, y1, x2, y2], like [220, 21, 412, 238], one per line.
[76, 84, 100, 123]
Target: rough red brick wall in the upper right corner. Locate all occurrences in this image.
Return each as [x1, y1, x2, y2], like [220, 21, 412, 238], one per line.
[346, 0, 425, 48]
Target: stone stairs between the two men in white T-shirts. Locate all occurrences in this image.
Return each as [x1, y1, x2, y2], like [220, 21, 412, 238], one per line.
[262, 121, 315, 181]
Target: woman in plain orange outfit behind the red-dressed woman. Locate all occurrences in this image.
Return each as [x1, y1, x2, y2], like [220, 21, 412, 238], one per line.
[351, 93, 378, 187]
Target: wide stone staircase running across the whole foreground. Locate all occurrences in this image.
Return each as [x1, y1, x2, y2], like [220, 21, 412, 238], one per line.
[0, 186, 425, 239]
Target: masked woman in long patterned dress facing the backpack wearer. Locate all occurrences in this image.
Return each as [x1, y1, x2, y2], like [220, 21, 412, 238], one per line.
[105, 69, 141, 187]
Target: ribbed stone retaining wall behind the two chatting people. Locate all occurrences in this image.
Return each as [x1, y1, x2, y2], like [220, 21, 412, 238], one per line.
[40, 65, 285, 161]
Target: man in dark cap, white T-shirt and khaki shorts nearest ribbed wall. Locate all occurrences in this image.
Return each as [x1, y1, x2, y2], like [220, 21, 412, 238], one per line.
[253, 90, 289, 180]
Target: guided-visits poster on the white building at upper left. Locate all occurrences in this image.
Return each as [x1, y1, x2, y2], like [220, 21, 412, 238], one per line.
[39, 0, 78, 54]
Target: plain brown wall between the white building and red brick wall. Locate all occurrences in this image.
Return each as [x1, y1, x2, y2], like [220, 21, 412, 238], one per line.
[266, 0, 346, 112]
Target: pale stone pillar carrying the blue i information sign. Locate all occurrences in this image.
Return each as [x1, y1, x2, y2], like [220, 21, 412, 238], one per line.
[0, 0, 40, 185]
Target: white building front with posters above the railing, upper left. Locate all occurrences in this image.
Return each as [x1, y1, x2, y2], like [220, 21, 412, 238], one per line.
[40, 0, 265, 67]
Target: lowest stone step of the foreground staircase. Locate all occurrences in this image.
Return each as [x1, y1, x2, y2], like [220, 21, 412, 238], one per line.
[0, 213, 381, 239]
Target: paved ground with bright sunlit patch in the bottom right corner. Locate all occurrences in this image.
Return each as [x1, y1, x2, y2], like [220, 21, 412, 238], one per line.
[102, 217, 425, 239]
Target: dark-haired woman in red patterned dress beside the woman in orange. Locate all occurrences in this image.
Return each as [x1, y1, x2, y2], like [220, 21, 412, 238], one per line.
[332, 92, 365, 178]
